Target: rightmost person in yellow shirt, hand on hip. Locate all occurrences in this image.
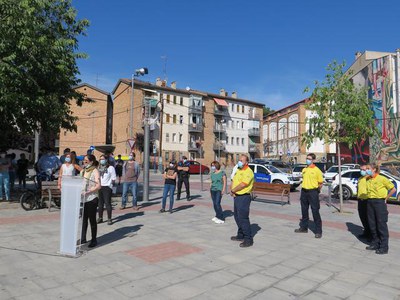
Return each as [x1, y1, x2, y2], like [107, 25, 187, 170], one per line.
[366, 164, 396, 254]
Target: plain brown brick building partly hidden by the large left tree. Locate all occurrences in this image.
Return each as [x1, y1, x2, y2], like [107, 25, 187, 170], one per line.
[59, 83, 113, 155]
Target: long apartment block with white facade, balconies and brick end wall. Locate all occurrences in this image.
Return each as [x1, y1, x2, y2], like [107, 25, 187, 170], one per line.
[112, 79, 264, 164]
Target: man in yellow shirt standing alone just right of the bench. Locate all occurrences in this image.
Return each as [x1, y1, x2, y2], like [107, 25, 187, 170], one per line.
[294, 153, 323, 239]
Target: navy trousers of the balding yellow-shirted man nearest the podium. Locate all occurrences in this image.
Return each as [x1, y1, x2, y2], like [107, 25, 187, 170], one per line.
[233, 195, 253, 242]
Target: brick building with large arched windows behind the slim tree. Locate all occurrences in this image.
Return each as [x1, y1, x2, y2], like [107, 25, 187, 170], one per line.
[263, 99, 336, 163]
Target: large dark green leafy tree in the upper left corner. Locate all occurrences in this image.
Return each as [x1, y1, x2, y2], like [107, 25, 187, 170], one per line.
[0, 0, 89, 146]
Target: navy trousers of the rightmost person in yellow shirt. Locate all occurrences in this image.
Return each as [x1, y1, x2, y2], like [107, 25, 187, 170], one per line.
[367, 199, 389, 250]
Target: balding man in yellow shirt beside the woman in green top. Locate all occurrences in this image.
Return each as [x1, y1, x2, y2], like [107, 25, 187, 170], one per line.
[230, 154, 254, 248]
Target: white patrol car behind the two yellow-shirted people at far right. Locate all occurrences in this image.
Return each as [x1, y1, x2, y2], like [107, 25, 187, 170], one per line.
[332, 170, 400, 201]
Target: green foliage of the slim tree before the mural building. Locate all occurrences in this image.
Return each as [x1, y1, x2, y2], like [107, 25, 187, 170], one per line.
[302, 61, 376, 148]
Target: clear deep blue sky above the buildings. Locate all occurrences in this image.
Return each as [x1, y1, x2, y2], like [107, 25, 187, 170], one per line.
[72, 0, 400, 110]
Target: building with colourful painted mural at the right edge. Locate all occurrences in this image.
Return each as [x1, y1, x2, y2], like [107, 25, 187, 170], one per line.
[346, 49, 400, 163]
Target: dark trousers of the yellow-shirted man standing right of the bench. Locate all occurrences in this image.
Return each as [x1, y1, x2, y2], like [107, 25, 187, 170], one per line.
[300, 189, 322, 234]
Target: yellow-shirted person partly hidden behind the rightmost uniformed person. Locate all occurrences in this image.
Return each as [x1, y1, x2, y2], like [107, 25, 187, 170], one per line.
[357, 165, 371, 240]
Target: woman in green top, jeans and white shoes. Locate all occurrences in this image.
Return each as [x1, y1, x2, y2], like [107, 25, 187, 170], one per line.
[210, 161, 226, 224]
